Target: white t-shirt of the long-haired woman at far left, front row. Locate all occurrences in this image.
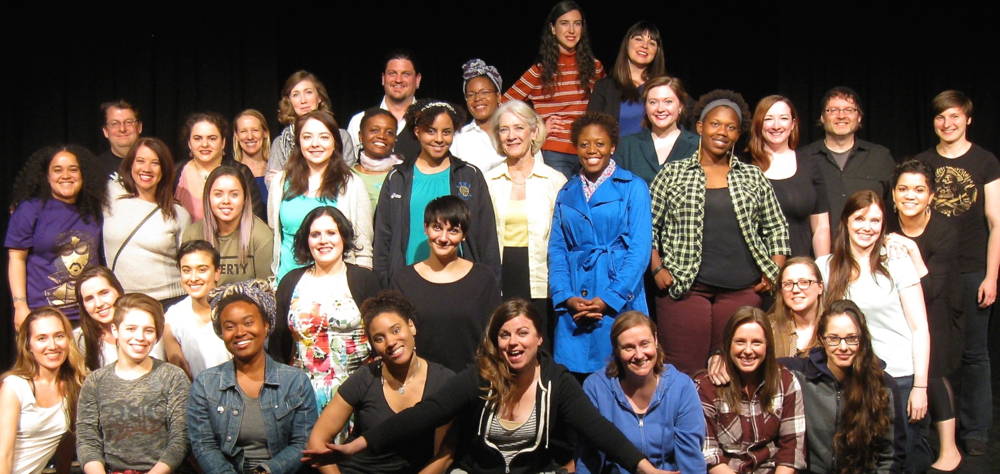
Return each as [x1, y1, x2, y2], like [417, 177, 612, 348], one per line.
[3, 375, 69, 474]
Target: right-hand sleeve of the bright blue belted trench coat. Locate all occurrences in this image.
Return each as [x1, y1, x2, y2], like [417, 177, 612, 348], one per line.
[601, 176, 653, 310]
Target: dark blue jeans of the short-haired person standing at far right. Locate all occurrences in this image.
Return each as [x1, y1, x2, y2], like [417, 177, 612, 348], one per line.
[958, 272, 993, 442]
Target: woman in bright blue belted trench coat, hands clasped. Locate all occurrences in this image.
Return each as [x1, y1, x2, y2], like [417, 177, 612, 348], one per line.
[549, 112, 651, 380]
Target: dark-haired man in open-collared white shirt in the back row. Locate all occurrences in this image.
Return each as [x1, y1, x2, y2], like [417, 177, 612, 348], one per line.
[347, 49, 420, 158]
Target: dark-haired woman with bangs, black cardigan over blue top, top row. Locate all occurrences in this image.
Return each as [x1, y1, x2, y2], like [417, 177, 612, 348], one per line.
[587, 20, 668, 137]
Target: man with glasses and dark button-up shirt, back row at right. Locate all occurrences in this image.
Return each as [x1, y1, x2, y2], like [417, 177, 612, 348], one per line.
[800, 86, 896, 231]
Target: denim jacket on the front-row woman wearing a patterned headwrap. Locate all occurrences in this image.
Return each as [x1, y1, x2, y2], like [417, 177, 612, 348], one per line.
[188, 354, 317, 474]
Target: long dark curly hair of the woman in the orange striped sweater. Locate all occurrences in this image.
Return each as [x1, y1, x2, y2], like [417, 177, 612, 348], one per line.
[544, 0, 597, 97]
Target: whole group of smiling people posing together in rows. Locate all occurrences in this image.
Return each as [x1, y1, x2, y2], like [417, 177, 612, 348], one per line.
[0, 1, 1000, 474]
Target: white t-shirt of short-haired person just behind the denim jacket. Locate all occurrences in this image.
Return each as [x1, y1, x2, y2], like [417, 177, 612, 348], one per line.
[166, 296, 233, 377]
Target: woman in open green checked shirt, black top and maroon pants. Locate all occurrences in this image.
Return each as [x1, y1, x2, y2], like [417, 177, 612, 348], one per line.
[650, 90, 789, 375]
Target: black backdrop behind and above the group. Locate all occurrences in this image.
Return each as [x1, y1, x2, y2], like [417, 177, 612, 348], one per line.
[0, 5, 1000, 367]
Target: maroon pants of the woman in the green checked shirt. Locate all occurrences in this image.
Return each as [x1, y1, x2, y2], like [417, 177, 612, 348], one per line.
[656, 283, 761, 376]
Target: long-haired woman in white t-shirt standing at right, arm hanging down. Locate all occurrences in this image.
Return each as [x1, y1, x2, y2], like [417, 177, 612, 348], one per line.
[816, 190, 930, 471]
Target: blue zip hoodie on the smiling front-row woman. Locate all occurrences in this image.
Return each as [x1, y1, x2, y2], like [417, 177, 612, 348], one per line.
[576, 364, 707, 474]
